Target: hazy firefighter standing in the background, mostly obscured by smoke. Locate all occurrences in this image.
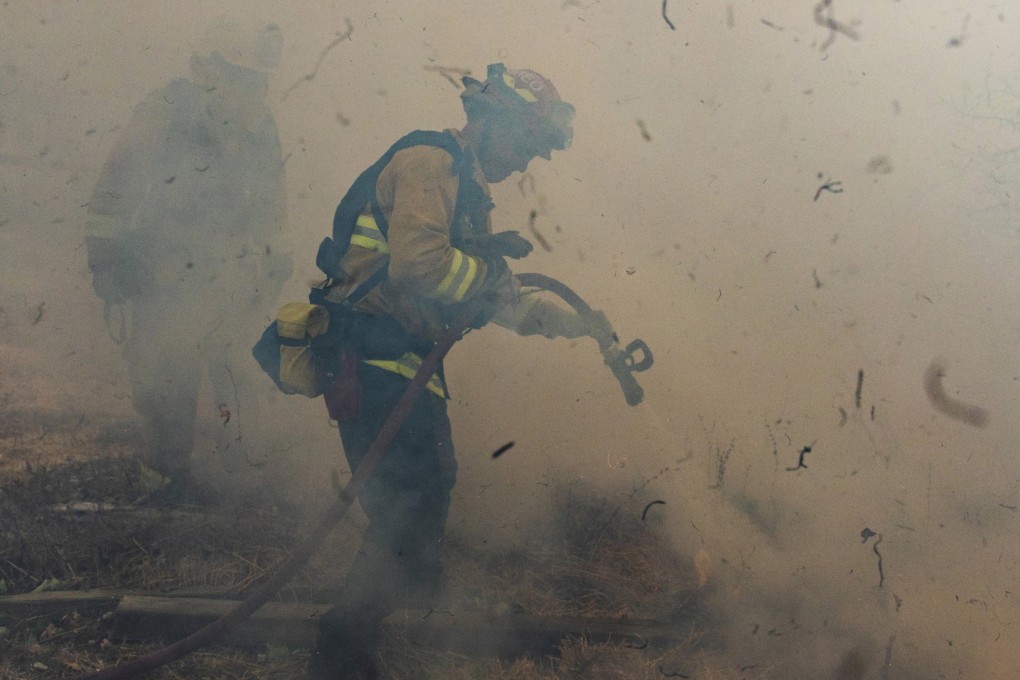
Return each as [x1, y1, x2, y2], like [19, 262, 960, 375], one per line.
[86, 21, 291, 499]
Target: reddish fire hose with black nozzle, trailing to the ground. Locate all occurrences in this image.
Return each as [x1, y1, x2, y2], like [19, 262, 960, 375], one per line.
[70, 274, 652, 680]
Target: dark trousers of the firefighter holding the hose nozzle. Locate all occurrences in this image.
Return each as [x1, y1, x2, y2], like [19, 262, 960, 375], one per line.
[311, 364, 457, 678]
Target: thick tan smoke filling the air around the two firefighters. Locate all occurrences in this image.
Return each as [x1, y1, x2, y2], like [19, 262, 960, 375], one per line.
[0, 0, 1020, 678]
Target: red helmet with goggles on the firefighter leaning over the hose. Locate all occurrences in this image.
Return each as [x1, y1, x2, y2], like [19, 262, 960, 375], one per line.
[460, 63, 574, 150]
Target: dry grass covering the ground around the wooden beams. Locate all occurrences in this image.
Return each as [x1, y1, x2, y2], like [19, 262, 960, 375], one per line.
[0, 409, 766, 680]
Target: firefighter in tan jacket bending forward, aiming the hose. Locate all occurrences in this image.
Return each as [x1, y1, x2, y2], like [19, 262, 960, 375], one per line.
[309, 64, 591, 680]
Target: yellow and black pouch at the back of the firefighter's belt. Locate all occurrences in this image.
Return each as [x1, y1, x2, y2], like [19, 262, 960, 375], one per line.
[252, 302, 329, 397]
